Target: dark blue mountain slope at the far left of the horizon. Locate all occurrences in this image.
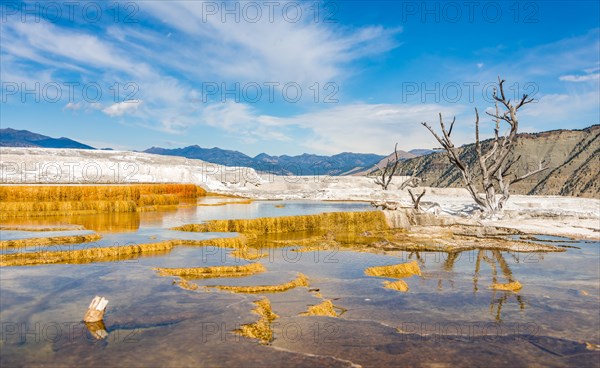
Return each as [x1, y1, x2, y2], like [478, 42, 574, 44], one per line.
[0, 128, 95, 149]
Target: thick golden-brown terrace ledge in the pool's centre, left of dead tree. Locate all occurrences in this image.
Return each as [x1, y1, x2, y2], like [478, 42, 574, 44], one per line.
[172, 211, 388, 235]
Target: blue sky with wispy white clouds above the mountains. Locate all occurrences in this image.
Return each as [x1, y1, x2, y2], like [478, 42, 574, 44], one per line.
[0, 1, 600, 155]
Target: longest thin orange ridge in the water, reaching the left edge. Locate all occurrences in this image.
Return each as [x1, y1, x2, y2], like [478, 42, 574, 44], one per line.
[0, 237, 246, 266]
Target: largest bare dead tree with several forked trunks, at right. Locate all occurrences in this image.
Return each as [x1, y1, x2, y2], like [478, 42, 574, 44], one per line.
[422, 78, 548, 217]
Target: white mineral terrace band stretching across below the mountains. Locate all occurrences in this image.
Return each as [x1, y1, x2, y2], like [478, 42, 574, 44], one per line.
[0, 147, 600, 240]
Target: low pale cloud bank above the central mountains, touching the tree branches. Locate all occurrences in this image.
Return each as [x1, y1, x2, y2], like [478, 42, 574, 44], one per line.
[203, 103, 472, 154]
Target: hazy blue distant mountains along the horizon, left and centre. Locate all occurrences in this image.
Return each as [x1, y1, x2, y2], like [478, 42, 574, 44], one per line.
[0, 128, 429, 175]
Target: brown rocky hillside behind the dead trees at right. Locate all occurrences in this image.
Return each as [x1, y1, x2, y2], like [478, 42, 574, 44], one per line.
[399, 125, 600, 198]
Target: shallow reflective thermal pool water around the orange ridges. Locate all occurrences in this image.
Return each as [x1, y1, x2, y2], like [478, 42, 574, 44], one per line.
[0, 198, 600, 367]
